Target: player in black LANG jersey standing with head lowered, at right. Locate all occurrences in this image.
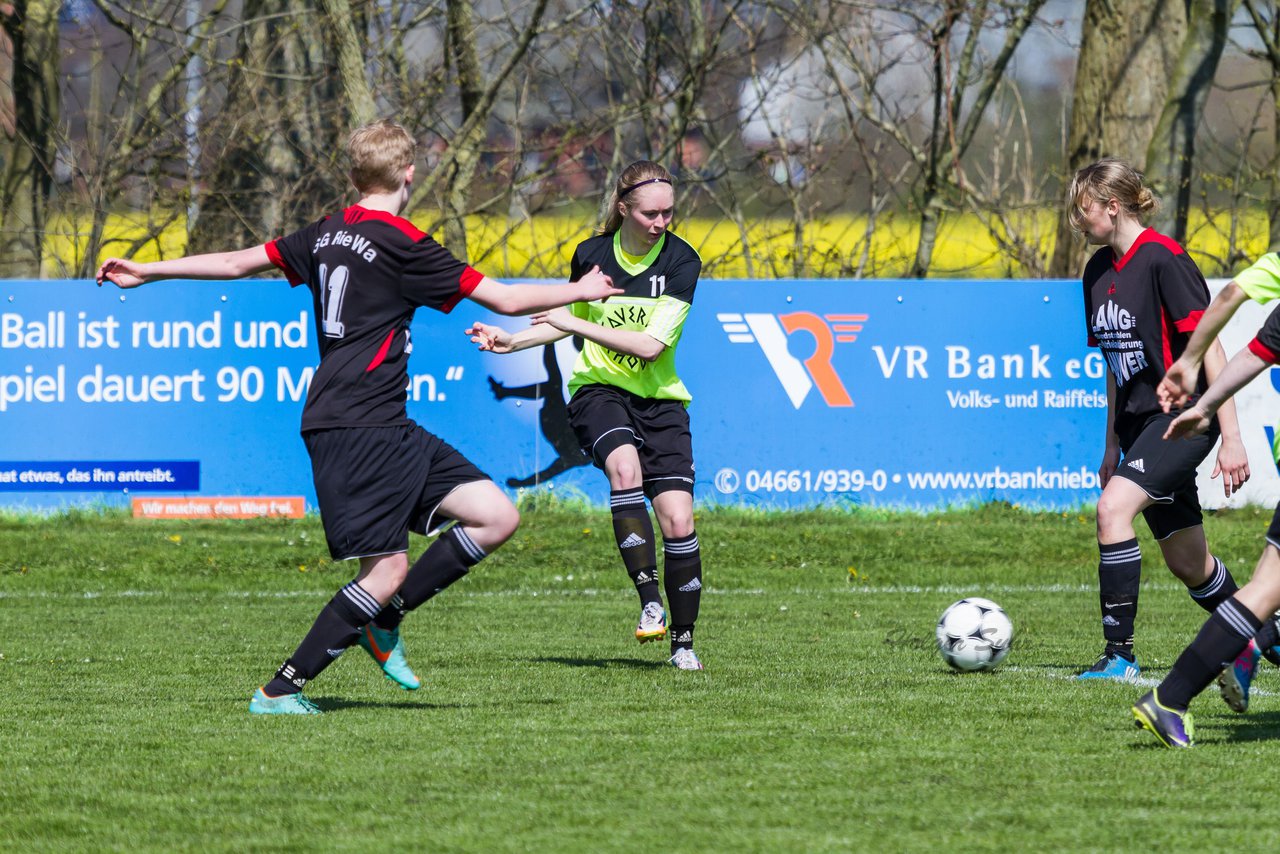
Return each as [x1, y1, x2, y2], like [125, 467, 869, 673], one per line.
[1068, 159, 1249, 681]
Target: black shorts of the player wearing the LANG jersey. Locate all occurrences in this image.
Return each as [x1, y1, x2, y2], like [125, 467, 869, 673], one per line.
[1115, 412, 1219, 540]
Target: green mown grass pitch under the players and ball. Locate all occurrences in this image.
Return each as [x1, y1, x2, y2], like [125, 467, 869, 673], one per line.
[0, 506, 1280, 851]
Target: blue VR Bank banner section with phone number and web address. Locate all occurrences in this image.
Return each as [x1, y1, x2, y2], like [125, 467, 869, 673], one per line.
[682, 280, 1106, 507]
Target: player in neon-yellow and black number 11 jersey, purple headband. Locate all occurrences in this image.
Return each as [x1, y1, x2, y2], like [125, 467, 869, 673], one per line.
[467, 160, 703, 670]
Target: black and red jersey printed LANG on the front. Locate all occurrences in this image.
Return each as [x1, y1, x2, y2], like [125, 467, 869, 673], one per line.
[1084, 228, 1208, 437]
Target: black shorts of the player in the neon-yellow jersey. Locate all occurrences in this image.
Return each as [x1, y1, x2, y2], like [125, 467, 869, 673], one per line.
[568, 385, 694, 498]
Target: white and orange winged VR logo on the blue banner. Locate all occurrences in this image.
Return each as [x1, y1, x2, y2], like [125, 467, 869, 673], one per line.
[716, 311, 868, 410]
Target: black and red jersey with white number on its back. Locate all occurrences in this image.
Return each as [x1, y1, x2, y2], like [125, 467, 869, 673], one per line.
[266, 205, 483, 433]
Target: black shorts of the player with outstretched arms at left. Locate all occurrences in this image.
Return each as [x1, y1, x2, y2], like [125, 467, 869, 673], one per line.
[302, 424, 489, 561]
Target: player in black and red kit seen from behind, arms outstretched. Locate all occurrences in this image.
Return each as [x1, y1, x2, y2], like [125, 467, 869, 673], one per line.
[97, 120, 621, 714]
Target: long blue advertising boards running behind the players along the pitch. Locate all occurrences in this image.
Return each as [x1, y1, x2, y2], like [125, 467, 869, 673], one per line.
[0, 280, 1261, 508]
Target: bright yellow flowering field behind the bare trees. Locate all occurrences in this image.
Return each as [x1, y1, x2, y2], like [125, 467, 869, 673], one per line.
[42, 211, 1267, 279]
